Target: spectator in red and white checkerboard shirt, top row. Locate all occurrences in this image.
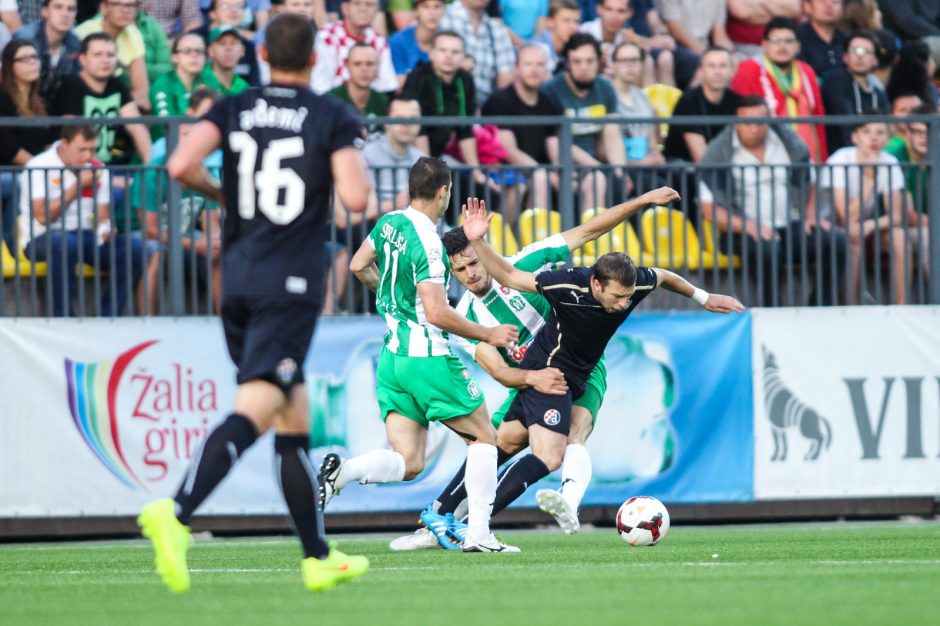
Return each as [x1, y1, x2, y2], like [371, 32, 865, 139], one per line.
[310, 0, 398, 94]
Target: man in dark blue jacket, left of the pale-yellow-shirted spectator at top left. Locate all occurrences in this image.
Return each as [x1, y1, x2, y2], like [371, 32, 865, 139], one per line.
[13, 0, 82, 101]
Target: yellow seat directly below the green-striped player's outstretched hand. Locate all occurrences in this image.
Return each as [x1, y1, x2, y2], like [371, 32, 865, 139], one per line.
[640, 206, 701, 270]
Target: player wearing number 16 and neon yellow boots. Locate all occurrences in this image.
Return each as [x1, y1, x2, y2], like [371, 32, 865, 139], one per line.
[138, 15, 369, 592]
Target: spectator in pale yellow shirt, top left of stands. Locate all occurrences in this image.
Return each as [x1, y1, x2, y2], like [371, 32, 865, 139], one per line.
[75, 0, 150, 113]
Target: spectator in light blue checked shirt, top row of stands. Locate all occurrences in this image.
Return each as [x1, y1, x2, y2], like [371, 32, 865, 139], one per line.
[440, 0, 516, 109]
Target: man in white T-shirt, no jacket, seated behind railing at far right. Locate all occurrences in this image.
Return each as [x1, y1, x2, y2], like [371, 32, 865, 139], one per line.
[820, 118, 916, 304]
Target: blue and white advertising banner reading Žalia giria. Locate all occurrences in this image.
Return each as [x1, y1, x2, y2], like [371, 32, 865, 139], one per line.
[0, 313, 754, 517]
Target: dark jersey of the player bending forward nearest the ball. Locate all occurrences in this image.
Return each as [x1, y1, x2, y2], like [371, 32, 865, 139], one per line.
[522, 267, 656, 398]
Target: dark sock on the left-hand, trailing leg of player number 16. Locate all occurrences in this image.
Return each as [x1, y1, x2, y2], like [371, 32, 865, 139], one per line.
[174, 413, 258, 526]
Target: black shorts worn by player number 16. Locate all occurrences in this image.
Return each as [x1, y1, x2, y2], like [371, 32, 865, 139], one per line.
[222, 296, 321, 395]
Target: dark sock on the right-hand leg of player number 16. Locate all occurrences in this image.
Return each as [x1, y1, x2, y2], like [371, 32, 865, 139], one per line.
[274, 435, 330, 559]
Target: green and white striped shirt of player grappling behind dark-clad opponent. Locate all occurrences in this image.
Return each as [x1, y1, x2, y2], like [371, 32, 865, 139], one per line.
[457, 235, 569, 360]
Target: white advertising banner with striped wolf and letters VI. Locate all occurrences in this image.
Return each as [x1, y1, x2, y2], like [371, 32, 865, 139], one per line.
[752, 307, 940, 499]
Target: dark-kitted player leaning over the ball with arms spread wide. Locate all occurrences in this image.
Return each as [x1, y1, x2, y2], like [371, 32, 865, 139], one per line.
[463, 196, 744, 528]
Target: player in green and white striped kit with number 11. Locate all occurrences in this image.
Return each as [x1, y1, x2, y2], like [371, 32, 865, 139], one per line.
[320, 157, 536, 552]
